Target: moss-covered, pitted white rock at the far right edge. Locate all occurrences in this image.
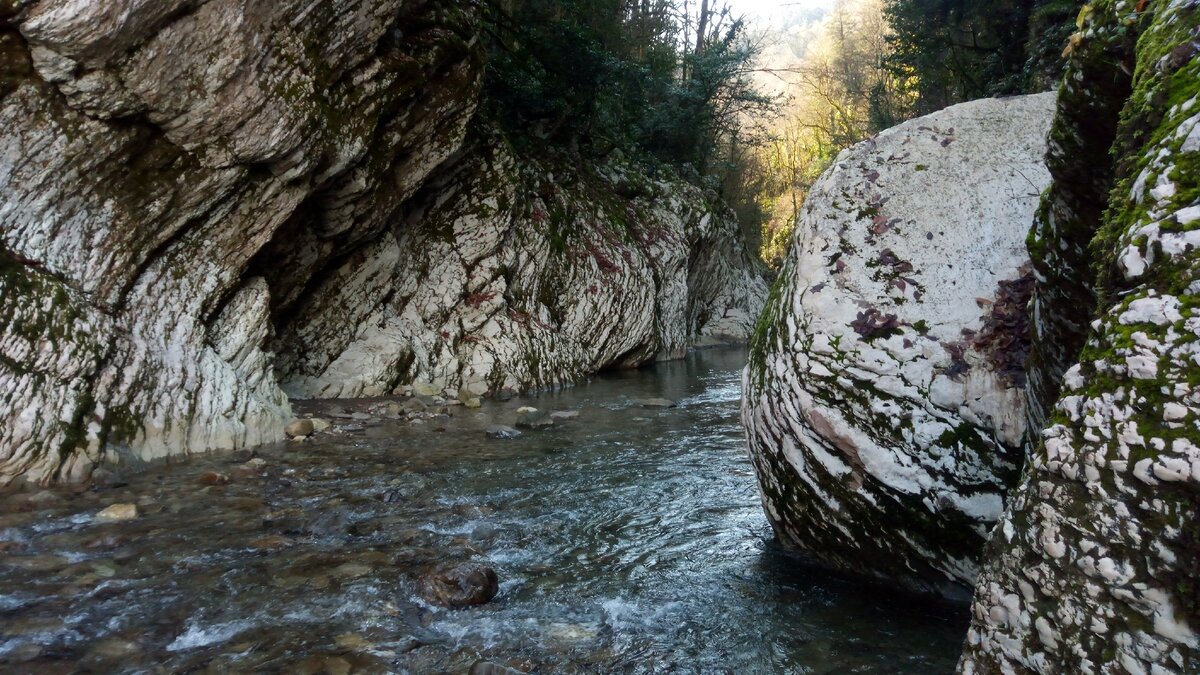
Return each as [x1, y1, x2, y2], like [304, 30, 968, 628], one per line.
[960, 0, 1200, 674]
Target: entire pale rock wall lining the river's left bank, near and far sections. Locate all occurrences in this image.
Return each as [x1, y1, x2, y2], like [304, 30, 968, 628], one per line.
[0, 0, 764, 485]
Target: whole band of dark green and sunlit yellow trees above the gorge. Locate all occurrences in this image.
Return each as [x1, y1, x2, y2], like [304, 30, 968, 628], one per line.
[482, 0, 1080, 264]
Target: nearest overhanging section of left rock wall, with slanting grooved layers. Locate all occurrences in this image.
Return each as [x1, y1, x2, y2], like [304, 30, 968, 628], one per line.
[0, 0, 481, 485]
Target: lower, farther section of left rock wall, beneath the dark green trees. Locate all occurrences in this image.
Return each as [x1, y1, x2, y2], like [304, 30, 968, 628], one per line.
[276, 137, 767, 398]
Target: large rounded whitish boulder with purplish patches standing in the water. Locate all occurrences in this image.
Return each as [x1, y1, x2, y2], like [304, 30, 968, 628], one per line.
[743, 90, 1054, 596]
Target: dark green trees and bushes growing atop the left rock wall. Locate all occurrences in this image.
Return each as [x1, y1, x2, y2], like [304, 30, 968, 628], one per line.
[485, 0, 770, 177]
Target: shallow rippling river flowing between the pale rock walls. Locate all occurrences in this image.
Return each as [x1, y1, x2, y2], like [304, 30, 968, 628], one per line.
[0, 351, 966, 675]
